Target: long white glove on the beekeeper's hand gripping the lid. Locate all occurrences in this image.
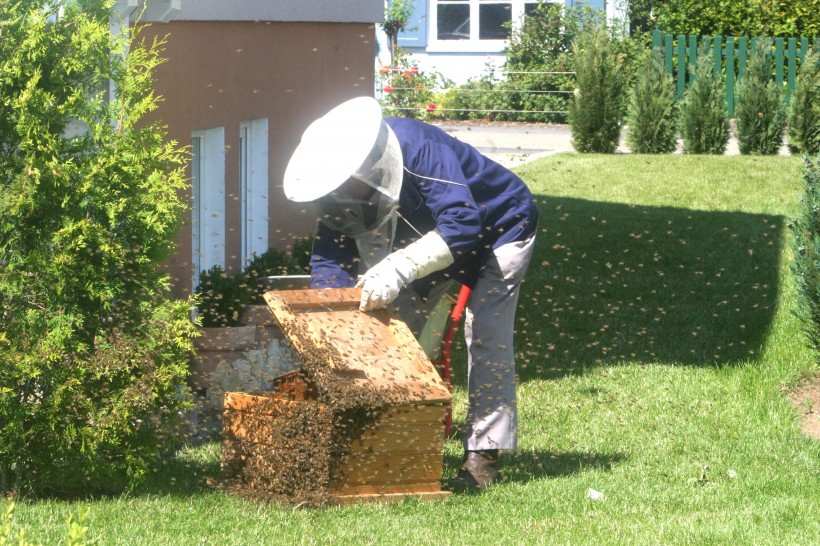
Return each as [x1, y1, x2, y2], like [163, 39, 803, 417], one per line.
[356, 231, 454, 311]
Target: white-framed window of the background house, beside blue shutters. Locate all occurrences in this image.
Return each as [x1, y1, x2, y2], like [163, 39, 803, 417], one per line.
[430, 0, 538, 51]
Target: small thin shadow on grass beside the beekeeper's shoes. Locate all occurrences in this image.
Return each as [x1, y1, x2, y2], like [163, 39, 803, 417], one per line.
[444, 450, 626, 483]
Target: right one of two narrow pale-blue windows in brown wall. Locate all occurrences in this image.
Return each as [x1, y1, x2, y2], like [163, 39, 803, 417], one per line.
[239, 118, 268, 266]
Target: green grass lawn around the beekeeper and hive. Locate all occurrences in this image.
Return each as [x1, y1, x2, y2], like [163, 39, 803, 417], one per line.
[8, 154, 820, 546]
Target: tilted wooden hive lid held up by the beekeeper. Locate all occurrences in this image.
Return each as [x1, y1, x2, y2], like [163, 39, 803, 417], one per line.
[264, 288, 450, 402]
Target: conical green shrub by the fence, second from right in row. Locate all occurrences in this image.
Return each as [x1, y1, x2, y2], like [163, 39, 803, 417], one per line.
[735, 39, 786, 155]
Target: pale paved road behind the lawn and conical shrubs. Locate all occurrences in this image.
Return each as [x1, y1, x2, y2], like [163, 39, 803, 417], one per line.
[434, 121, 789, 167]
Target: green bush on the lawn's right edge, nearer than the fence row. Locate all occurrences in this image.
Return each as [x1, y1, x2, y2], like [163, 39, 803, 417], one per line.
[789, 156, 820, 362]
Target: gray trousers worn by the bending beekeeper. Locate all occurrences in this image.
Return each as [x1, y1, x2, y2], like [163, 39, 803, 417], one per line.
[394, 235, 535, 450]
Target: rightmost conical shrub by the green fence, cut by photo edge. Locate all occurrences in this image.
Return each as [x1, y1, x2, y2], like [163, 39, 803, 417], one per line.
[787, 50, 820, 155]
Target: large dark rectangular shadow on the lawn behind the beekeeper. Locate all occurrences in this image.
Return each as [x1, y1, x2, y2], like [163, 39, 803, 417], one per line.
[453, 196, 785, 384]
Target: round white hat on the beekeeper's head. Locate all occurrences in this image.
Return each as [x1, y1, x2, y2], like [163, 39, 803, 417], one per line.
[284, 97, 401, 202]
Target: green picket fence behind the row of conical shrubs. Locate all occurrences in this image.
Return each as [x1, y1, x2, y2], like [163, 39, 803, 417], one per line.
[652, 30, 820, 117]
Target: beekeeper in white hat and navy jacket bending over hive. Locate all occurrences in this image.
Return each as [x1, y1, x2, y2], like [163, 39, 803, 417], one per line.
[284, 97, 538, 489]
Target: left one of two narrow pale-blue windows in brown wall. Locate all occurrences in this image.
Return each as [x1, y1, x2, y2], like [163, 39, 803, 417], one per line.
[191, 127, 225, 289]
